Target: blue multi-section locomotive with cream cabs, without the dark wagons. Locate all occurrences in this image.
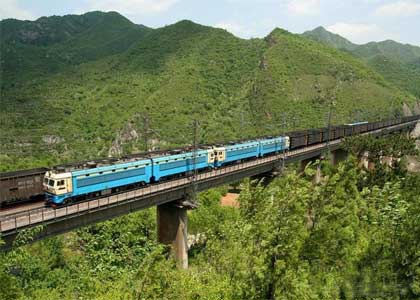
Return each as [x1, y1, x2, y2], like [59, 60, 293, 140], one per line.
[44, 136, 290, 206]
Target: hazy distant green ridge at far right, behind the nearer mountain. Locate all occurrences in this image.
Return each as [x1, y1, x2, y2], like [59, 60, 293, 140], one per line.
[302, 27, 420, 98]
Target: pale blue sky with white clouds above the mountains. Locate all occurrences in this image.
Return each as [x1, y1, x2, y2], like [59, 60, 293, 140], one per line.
[0, 0, 420, 46]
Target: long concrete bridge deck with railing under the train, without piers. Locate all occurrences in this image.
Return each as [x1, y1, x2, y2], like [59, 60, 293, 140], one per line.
[0, 121, 417, 247]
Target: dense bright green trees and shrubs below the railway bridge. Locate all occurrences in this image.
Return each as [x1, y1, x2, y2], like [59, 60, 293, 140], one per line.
[0, 137, 420, 300]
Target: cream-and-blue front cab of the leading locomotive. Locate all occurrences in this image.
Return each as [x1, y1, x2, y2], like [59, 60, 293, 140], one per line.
[43, 171, 73, 204]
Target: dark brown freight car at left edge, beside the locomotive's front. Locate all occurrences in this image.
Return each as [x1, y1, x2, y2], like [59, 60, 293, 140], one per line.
[0, 168, 48, 207]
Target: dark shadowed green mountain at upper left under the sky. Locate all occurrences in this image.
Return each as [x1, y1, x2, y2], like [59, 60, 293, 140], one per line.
[0, 11, 151, 86]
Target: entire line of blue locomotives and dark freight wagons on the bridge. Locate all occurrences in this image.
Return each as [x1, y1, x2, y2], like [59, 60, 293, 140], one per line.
[0, 116, 420, 207]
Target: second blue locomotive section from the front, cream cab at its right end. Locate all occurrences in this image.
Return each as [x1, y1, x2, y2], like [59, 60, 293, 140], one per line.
[152, 149, 214, 181]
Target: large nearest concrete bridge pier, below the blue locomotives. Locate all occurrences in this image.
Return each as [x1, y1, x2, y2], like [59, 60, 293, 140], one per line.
[157, 200, 196, 269]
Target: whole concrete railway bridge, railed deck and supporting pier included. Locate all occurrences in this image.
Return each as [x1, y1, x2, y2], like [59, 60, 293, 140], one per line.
[0, 120, 418, 268]
